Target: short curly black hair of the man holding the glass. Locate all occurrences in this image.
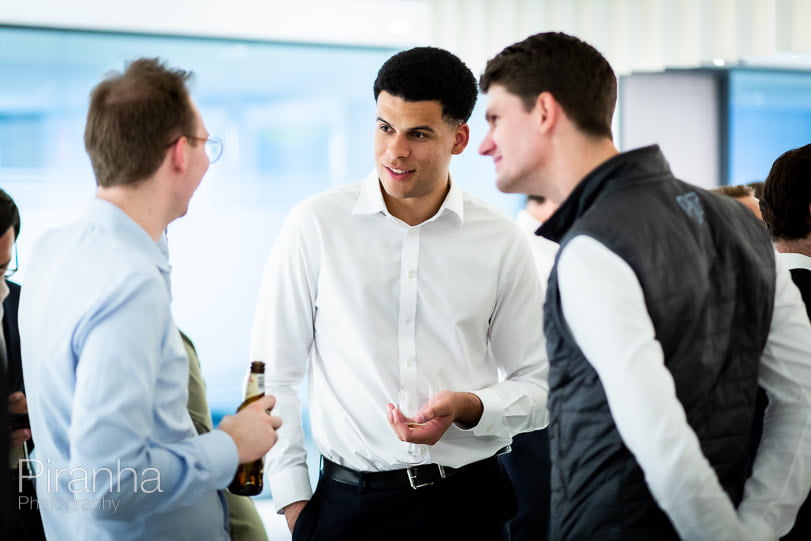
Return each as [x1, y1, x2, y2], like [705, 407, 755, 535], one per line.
[374, 47, 478, 123]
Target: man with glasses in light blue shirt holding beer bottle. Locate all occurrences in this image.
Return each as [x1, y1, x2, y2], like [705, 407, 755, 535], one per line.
[19, 59, 281, 541]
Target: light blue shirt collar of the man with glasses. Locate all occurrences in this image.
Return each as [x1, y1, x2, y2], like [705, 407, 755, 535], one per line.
[84, 198, 171, 273]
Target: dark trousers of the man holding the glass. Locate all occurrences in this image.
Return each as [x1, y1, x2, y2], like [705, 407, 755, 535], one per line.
[293, 459, 516, 541]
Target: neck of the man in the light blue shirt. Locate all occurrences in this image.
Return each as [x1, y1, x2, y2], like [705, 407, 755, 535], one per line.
[96, 180, 171, 242]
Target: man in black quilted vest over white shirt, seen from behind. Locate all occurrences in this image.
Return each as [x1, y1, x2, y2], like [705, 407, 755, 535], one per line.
[479, 33, 811, 540]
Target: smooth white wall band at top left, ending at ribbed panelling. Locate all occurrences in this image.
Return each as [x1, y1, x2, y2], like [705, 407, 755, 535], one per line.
[0, 0, 430, 46]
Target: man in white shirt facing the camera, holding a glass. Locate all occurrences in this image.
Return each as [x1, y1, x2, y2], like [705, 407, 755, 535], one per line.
[252, 47, 547, 540]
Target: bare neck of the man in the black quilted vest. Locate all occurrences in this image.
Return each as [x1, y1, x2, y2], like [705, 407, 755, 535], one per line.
[547, 132, 619, 204]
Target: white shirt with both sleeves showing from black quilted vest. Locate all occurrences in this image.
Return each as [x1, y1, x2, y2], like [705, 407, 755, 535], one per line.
[557, 236, 811, 541]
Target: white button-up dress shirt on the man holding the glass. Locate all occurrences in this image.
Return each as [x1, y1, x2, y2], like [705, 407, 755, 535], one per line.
[252, 174, 548, 508]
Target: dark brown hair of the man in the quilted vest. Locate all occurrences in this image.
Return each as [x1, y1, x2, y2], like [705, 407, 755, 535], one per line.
[479, 32, 617, 137]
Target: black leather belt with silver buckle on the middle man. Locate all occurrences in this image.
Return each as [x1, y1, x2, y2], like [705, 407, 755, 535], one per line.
[321, 446, 510, 490]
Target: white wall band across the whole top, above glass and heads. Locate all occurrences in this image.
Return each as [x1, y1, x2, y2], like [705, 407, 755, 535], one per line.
[6, 0, 811, 78]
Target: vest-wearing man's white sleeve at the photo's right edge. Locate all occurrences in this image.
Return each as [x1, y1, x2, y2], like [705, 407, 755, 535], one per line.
[738, 258, 811, 538]
